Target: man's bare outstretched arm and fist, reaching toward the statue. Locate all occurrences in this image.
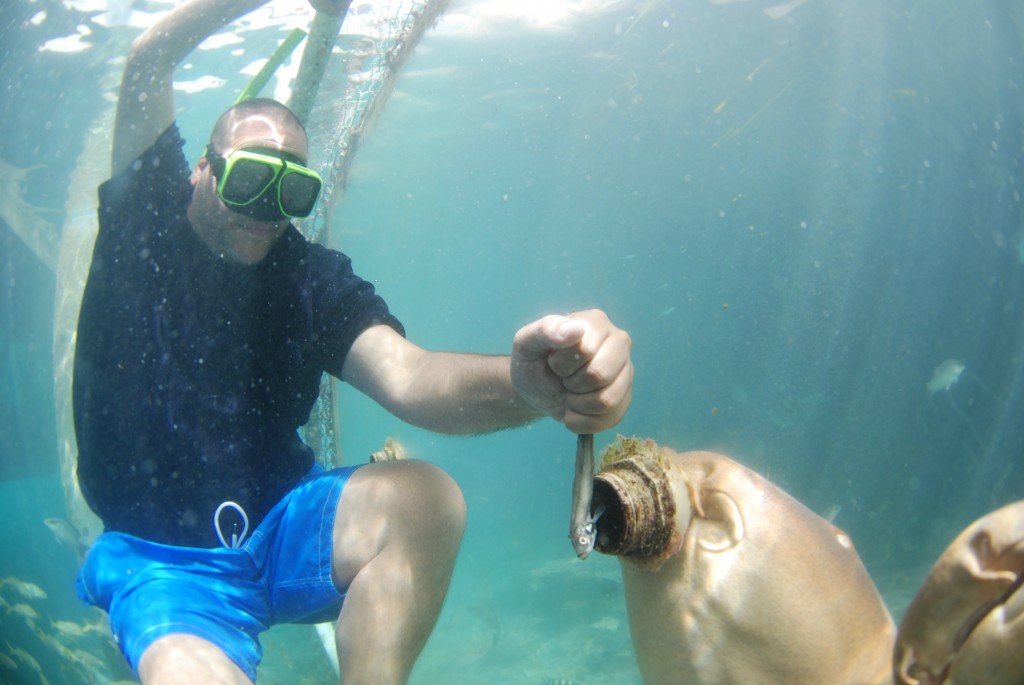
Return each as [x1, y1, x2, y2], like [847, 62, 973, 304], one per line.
[342, 310, 633, 433]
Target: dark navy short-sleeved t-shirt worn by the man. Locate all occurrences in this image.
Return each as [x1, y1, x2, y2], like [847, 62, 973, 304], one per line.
[74, 126, 403, 547]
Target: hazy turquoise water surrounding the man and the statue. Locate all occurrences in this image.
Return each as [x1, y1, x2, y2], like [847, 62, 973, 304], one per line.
[0, 0, 1024, 684]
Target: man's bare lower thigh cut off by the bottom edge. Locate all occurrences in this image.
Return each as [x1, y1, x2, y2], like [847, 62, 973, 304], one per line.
[138, 634, 252, 685]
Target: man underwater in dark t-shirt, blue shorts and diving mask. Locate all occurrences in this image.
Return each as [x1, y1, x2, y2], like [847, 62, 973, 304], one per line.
[74, 0, 633, 685]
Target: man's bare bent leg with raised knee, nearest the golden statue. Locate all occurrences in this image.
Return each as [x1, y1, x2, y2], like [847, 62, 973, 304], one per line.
[332, 461, 466, 685]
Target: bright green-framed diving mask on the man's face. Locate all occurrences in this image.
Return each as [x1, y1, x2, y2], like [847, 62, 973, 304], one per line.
[206, 145, 323, 221]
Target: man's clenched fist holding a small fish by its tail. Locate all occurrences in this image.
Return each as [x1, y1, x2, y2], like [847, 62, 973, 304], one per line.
[512, 309, 633, 433]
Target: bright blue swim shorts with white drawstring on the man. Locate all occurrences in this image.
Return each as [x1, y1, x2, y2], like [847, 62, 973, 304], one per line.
[75, 466, 358, 681]
